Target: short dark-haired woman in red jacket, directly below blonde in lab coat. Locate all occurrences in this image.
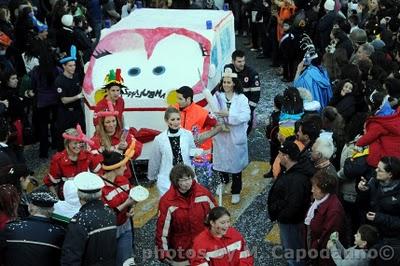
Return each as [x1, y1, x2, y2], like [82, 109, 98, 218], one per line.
[155, 164, 216, 265]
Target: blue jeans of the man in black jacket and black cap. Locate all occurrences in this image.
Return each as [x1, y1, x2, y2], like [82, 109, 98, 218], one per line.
[279, 223, 305, 266]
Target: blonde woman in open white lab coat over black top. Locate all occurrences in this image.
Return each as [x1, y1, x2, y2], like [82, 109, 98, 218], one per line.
[147, 107, 196, 197]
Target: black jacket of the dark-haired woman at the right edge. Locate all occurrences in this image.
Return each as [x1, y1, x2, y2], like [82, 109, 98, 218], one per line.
[359, 178, 400, 239]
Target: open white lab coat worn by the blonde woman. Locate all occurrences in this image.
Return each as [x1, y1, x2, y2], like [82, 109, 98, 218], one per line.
[147, 128, 196, 197]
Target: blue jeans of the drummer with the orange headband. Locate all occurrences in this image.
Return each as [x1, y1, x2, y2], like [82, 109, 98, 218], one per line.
[116, 219, 133, 266]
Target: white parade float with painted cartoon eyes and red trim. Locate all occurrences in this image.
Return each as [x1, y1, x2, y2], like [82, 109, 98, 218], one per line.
[83, 8, 235, 160]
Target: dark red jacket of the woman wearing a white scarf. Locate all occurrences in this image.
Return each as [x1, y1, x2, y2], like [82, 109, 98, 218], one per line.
[310, 194, 344, 265]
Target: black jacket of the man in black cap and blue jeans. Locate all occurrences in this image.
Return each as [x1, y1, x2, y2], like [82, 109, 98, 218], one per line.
[268, 160, 314, 224]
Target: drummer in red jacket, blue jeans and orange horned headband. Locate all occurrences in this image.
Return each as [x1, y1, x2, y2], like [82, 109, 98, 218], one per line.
[102, 151, 136, 265]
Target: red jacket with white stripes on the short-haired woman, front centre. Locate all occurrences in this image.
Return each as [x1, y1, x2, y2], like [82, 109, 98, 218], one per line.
[155, 180, 217, 261]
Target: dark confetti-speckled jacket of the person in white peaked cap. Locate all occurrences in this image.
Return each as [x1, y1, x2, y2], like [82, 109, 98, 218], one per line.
[61, 200, 117, 266]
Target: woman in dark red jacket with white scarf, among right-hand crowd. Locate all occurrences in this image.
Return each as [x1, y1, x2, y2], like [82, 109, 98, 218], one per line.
[304, 170, 344, 265]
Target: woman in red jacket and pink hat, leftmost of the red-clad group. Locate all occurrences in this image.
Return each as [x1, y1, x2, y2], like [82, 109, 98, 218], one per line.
[43, 125, 103, 199]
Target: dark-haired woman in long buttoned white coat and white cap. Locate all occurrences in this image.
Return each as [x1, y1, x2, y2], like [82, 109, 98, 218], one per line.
[213, 69, 250, 204]
